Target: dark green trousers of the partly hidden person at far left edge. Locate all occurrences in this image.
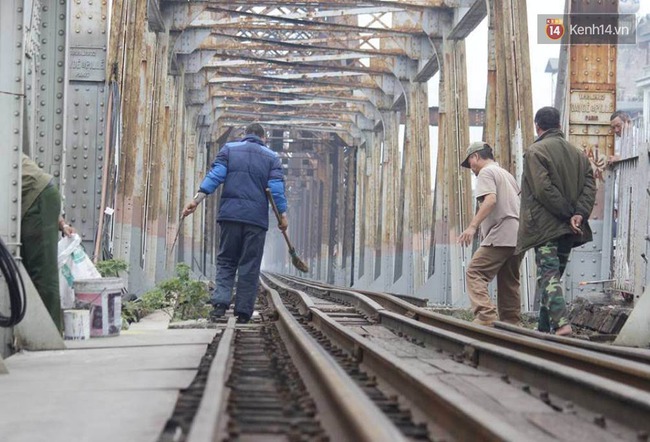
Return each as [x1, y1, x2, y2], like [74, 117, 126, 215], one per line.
[20, 185, 63, 330]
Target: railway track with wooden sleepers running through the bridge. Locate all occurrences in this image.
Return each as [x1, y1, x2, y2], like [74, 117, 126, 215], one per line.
[170, 275, 650, 442]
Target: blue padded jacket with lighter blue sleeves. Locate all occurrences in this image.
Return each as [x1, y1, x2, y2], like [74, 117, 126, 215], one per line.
[199, 135, 287, 230]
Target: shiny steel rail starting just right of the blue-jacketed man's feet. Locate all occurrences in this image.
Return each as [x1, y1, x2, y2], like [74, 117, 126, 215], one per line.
[262, 281, 406, 442]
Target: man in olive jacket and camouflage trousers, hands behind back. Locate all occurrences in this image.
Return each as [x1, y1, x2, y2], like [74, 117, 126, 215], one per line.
[515, 107, 596, 335]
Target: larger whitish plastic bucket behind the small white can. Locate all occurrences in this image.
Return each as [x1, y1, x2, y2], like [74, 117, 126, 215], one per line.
[74, 278, 124, 337]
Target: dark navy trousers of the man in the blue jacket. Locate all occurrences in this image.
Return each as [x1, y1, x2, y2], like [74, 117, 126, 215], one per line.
[211, 221, 266, 318]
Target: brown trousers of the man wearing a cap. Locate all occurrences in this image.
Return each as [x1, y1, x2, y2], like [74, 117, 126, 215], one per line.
[465, 246, 521, 324]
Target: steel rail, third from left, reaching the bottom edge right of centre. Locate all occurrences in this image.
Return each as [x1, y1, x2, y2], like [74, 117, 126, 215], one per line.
[264, 275, 526, 441]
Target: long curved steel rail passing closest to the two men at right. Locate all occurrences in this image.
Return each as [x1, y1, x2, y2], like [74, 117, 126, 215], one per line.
[274, 276, 650, 392]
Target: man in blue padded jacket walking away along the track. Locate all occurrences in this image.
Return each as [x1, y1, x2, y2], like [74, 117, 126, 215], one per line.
[183, 123, 289, 323]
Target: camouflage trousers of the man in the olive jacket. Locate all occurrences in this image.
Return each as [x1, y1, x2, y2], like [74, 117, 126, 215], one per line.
[535, 235, 573, 332]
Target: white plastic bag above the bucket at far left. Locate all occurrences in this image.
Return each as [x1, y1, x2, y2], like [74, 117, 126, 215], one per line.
[58, 234, 102, 309]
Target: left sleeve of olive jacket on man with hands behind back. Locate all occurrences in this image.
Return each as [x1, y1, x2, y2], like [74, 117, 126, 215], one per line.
[524, 151, 573, 221]
